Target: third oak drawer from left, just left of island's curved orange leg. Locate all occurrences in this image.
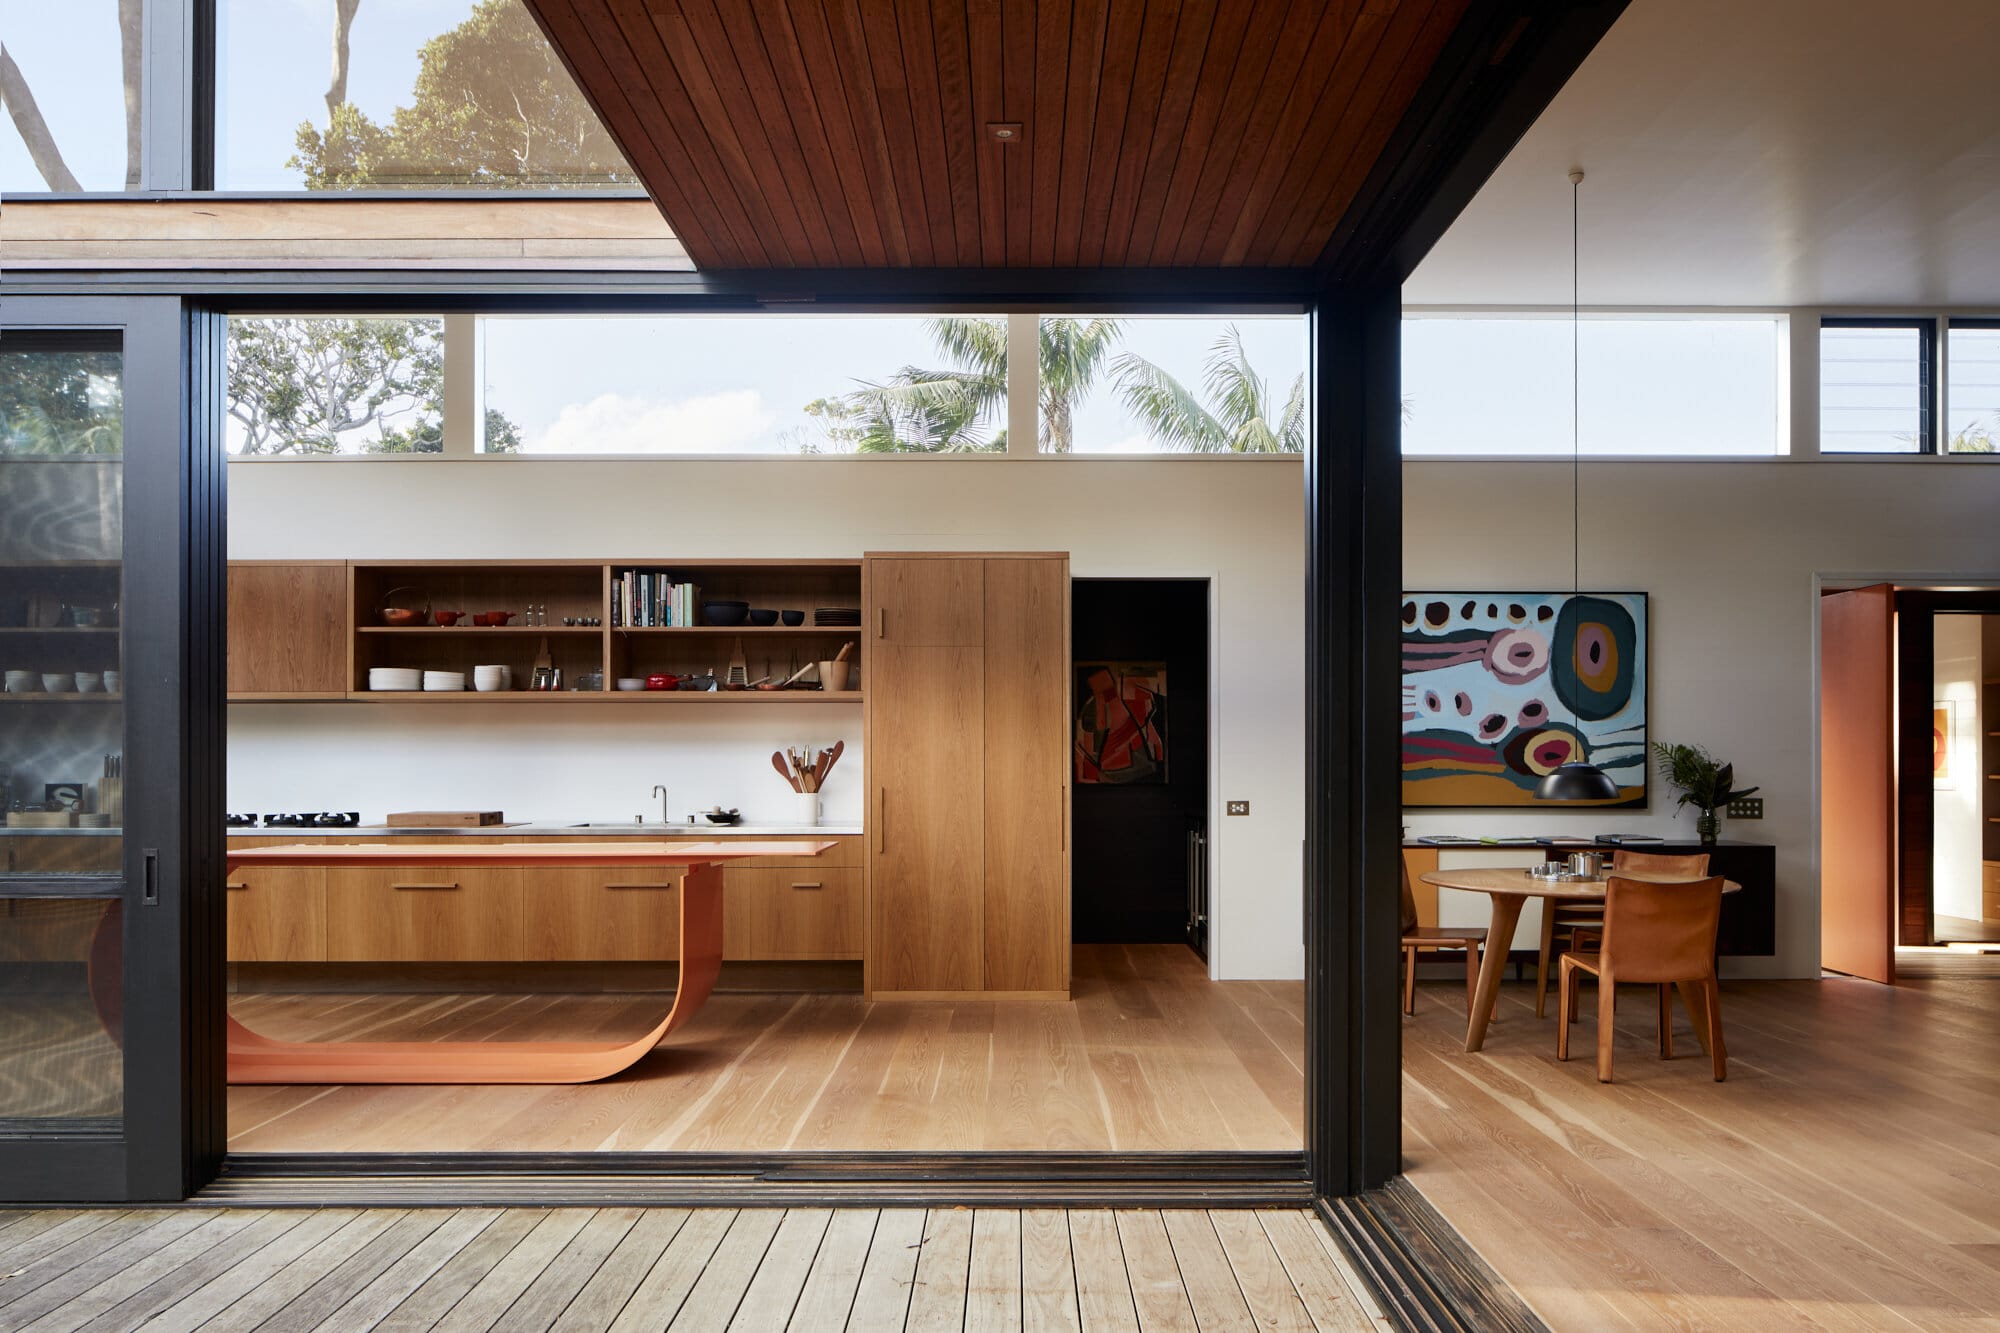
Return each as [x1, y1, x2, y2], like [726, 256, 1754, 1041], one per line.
[506, 865, 682, 963]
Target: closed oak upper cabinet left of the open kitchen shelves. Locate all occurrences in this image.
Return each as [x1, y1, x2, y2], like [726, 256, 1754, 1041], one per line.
[228, 560, 350, 699]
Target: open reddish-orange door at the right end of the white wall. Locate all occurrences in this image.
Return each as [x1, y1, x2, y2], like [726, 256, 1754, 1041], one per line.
[1820, 584, 1896, 983]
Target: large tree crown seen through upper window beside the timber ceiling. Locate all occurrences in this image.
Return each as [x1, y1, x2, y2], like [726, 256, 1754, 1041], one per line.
[288, 0, 636, 190]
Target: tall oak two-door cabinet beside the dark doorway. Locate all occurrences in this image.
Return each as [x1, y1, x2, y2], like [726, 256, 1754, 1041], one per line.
[862, 554, 1070, 997]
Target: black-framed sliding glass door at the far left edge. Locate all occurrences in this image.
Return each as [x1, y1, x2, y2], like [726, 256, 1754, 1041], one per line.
[0, 298, 220, 1201]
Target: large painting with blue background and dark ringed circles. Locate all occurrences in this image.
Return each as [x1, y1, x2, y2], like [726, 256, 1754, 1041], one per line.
[1402, 592, 1648, 811]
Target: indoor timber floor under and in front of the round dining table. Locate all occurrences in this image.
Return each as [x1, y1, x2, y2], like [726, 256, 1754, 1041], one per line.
[1404, 964, 2000, 1331]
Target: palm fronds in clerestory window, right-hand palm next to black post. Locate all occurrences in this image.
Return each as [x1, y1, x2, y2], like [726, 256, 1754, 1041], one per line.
[1112, 324, 1306, 454]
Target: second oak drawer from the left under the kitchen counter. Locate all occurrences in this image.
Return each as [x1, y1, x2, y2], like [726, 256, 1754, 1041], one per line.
[326, 867, 524, 963]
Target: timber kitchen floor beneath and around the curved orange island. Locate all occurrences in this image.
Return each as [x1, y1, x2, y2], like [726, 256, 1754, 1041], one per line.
[230, 945, 1306, 1153]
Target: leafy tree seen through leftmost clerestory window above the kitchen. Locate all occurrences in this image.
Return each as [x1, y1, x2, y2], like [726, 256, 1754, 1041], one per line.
[228, 318, 522, 454]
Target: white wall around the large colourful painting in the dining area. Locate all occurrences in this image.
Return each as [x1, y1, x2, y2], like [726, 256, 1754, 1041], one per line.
[1404, 460, 2000, 977]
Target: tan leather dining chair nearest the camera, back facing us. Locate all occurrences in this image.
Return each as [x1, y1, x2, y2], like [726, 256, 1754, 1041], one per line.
[1556, 875, 1728, 1083]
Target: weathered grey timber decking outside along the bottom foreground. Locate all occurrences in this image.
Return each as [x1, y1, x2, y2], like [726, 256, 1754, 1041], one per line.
[0, 1209, 1388, 1333]
